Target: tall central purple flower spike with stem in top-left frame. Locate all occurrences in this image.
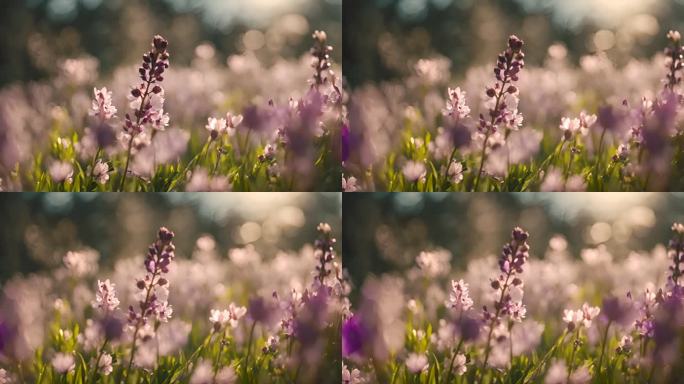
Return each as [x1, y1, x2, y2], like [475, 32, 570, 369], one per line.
[119, 35, 169, 192]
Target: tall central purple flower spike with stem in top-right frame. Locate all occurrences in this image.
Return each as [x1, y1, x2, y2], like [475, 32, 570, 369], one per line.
[473, 35, 525, 191]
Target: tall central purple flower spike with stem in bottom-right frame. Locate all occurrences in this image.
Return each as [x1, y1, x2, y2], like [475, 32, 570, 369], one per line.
[482, 227, 530, 369]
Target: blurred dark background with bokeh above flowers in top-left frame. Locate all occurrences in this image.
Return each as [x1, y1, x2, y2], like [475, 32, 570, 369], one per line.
[0, 0, 342, 86]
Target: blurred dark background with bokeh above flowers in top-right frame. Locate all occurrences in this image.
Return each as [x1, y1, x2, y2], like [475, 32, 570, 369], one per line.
[343, 0, 684, 86]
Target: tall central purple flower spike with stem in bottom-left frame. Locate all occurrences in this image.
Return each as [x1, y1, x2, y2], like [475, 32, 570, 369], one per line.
[124, 227, 176, 382]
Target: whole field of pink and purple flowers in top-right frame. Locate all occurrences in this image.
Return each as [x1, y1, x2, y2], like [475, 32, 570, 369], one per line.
[343, 32, 684, 192]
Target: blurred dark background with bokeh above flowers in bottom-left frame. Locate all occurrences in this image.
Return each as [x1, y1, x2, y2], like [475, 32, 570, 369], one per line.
[0, 193, 342, 285]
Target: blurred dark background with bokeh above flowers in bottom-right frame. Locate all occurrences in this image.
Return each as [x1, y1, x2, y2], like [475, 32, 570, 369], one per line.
[342, 192, 684, 292]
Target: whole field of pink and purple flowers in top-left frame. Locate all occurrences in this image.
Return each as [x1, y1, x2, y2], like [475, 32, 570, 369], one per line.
[0, 31, 340, 192]
